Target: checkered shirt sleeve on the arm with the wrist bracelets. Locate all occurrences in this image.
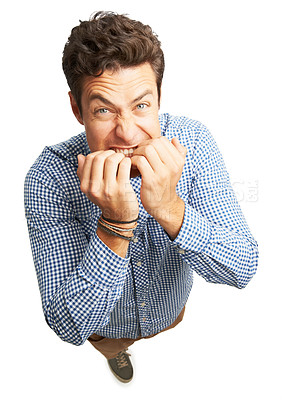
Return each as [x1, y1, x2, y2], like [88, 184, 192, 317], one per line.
[25, 169, 129, 345]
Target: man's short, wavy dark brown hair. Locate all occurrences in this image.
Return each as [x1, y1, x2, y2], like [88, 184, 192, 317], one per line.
[63, 11, 164, 113]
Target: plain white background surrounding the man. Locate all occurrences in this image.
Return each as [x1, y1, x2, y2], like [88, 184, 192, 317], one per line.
[0, 0, 282, 400]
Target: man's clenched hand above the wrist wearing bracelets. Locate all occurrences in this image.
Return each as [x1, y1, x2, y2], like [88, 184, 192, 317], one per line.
[77, 150, 139, 221]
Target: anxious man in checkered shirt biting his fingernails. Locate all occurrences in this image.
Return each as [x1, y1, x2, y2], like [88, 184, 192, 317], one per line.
[25, 12, 258, 382]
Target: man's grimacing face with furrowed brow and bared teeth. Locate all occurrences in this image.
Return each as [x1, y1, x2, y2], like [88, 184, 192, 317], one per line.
[70, 63, 160, 155]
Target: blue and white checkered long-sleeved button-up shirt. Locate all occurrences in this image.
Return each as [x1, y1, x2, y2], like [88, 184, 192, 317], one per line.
[25, 114, 258, 345]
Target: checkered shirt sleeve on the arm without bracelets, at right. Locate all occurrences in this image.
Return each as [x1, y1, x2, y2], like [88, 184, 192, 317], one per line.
[174, 126, 258, 288]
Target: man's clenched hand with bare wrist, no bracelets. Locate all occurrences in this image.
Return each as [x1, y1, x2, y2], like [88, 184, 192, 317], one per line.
[131, 136, 187, 220]
